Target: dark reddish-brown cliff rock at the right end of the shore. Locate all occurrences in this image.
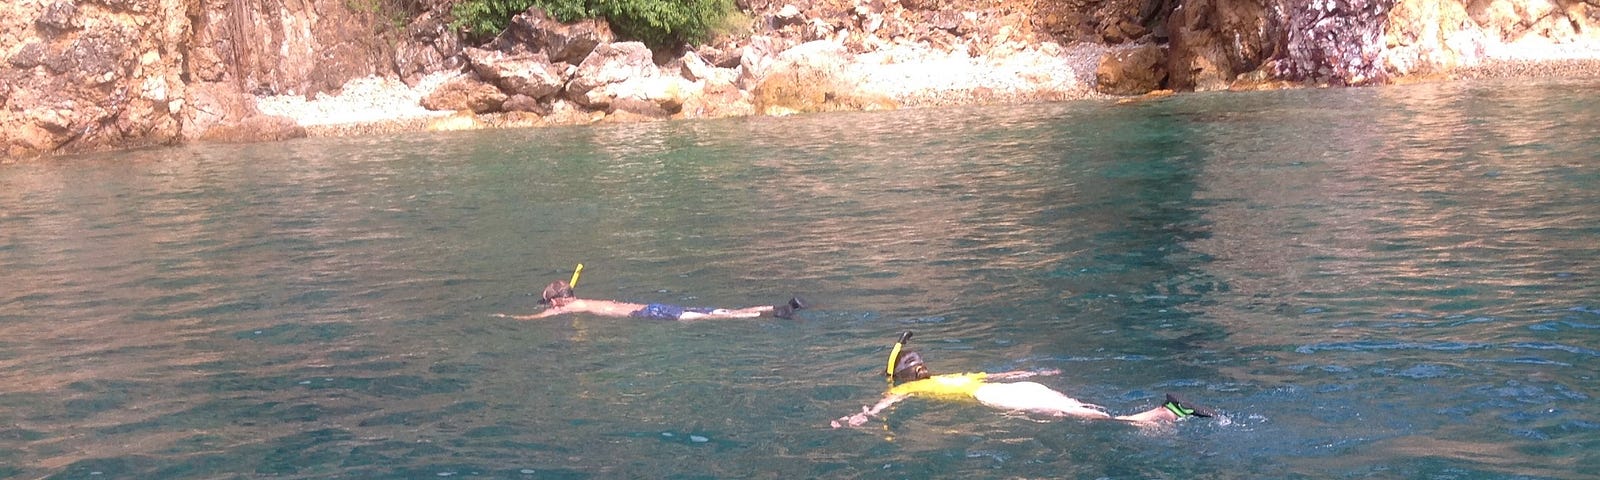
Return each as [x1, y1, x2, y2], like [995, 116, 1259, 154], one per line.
[1163, 0, 1600, 91]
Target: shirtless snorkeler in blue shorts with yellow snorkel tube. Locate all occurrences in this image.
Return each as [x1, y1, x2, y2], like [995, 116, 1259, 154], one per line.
[494, 280, 806, 322]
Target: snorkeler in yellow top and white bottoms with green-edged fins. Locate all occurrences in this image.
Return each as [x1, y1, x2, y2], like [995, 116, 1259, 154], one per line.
[832, 331, 1216, 429]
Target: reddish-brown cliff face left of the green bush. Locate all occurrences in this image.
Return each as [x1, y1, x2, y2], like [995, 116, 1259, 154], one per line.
[0, 0, 461, 157]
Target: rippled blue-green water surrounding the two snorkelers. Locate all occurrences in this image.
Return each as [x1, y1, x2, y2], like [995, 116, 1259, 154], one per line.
[0, 80, 1600, 478]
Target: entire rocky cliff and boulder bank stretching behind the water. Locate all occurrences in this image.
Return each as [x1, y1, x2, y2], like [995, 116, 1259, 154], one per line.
[0, 0, 1600, 157]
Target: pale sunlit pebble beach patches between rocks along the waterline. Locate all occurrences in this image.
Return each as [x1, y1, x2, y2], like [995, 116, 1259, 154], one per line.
[256, 43, 1600, 136]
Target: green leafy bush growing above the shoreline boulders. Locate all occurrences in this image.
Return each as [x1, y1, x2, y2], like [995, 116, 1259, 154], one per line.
[450, 0, 734, 46]
